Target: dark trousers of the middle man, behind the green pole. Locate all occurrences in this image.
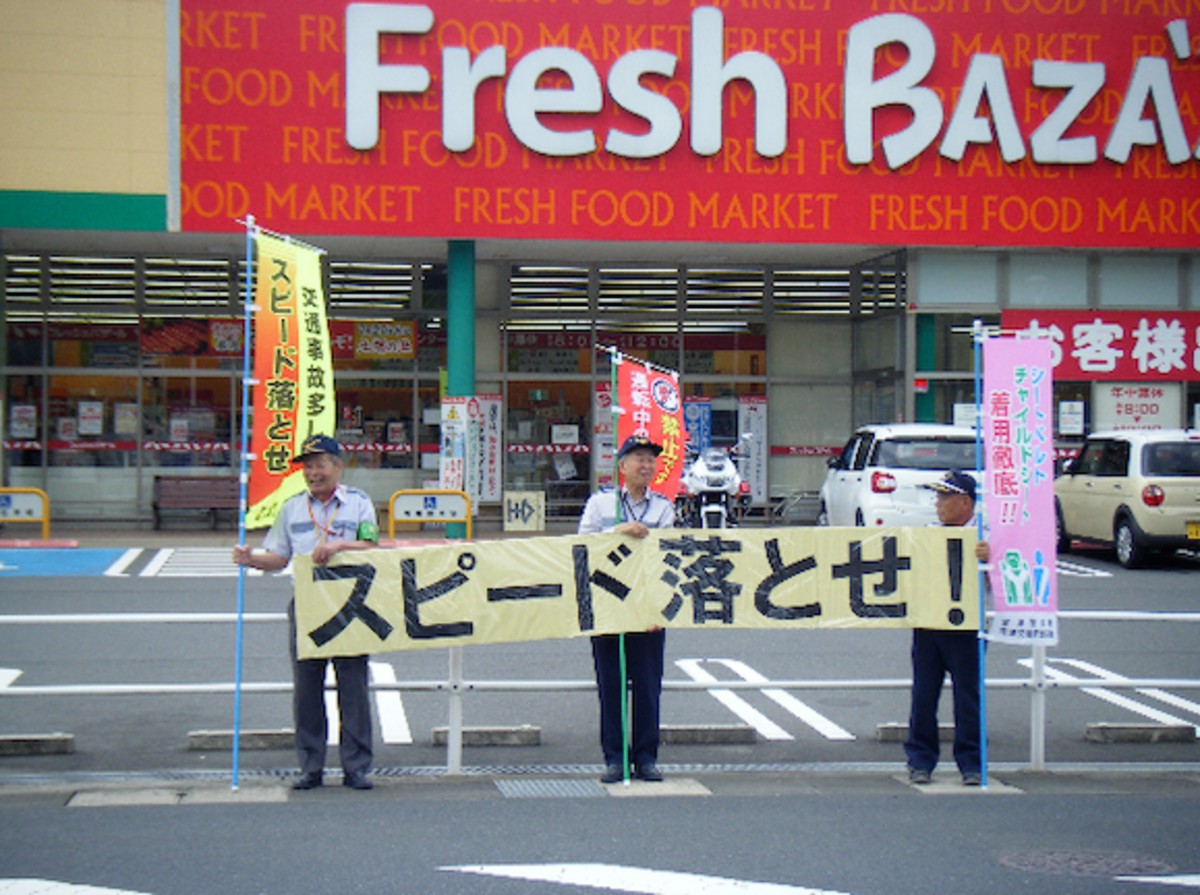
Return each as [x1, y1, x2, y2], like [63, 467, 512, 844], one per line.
[592, 631, 667, 767]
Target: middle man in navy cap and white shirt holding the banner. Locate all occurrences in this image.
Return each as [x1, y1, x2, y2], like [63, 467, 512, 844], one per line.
[580, 436, 674, 783]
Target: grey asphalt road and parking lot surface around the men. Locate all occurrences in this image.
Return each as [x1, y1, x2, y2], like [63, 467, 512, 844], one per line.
[0, 537, 1200, 895]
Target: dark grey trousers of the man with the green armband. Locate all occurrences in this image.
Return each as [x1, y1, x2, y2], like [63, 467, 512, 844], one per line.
[288, 603, 373, 774]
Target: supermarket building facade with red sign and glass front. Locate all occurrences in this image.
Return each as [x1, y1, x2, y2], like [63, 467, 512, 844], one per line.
[0, 0, 1200, 518]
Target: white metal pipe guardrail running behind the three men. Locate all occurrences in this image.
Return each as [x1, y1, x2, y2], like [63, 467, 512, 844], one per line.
[0, 609, 1200, 774]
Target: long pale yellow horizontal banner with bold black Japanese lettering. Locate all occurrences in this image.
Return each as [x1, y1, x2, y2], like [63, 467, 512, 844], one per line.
[294, 527, 979, 659]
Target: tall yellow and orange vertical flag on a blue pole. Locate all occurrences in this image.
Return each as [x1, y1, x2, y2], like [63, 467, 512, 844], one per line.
[246, 233, 337, 529]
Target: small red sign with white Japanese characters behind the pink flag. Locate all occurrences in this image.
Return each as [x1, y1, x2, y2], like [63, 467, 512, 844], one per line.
[1001, 311, 1200, 383]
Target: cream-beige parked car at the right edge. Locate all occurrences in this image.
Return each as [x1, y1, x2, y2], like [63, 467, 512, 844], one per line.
[1054, 430, 1200, 569]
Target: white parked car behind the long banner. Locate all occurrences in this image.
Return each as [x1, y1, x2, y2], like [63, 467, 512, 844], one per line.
[817, 422, 978, 525]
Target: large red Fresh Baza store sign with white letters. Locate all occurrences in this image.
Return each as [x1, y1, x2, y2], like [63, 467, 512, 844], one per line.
[178, 0, 1200, 248]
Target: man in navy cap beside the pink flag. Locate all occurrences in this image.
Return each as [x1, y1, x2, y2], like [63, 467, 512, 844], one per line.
[904, 469, 990, 786]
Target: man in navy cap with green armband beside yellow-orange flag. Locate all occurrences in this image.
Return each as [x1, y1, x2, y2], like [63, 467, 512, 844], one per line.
[233, 436, 379, 789]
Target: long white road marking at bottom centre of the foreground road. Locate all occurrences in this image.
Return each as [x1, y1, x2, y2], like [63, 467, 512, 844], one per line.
[439, 864, 846, 895]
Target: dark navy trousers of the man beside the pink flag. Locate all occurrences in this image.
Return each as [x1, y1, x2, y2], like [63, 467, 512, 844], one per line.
[904, 627, 980, 774]
